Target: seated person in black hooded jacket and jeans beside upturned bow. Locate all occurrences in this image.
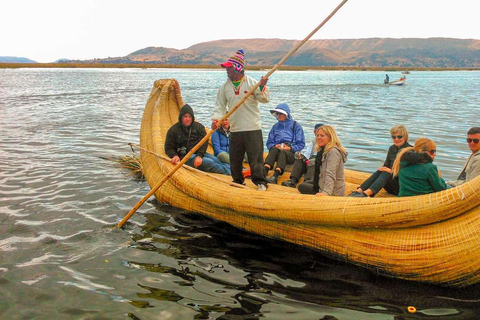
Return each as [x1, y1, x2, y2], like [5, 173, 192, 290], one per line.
[165, 104, 230, 174]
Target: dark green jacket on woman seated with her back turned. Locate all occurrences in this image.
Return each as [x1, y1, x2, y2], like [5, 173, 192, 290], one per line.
[398, 151, 447, 197]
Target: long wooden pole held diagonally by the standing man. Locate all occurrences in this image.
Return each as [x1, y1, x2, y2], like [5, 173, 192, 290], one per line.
[117, 0, 348, 227]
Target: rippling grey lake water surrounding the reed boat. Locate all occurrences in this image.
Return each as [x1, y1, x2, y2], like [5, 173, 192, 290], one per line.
[0, 69, 480, 319]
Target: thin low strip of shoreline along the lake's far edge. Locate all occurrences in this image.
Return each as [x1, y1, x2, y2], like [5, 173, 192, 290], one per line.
[0, 63, 480, 72]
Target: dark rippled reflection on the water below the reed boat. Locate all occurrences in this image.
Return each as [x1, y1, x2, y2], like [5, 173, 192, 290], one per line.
[124, 201, 480, 319]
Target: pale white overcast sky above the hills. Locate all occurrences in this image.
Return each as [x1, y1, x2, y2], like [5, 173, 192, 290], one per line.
[0, 0, 480, 62]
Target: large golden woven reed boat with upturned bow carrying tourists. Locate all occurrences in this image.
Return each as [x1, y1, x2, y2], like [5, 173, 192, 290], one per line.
[140, 79, 480, 287]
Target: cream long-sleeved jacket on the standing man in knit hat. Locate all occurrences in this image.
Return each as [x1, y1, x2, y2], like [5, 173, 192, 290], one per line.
[213, 75, 270, 132]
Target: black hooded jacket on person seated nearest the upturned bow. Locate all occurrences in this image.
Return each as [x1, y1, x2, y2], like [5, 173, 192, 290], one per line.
[165, 104, 208, 159]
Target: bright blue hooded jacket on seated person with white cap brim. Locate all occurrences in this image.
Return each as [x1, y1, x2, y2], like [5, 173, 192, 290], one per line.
[267, 103, 305, 152]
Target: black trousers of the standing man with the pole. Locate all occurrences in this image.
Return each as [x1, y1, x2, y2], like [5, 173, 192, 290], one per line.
[230, 130, 268, 185]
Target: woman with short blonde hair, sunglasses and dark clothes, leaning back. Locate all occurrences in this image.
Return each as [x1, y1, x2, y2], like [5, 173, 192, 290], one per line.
[348, 125, 412, 197]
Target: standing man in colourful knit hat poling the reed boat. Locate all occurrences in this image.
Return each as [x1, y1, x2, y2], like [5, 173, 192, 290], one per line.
[212, 49, 270, 191]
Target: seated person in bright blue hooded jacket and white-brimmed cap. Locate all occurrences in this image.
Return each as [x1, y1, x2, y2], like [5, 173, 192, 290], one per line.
[264, 103, 305, 184]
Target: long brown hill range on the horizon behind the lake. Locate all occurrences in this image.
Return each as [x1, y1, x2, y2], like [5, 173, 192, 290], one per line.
[76, 38, 480, 68]
